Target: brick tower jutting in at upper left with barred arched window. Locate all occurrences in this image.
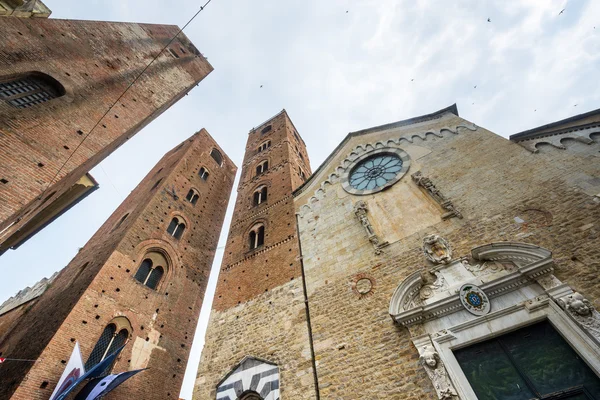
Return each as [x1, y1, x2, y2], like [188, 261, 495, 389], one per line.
[0, 16, 212, 253]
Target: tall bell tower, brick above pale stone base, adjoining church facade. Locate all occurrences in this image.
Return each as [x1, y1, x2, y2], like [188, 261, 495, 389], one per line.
[193, 110, 312, 400]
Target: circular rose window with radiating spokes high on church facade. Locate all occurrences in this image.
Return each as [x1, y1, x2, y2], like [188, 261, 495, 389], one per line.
[349, 153, 402, 190]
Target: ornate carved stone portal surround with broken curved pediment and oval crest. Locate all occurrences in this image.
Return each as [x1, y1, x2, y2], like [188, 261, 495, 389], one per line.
[389, 235, 600, 400]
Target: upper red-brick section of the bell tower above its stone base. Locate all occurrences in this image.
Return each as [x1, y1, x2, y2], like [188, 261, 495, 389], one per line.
[213, 110, 311, 311]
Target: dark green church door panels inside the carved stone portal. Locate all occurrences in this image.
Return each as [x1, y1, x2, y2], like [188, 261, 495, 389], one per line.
[454, 320, 600, 400]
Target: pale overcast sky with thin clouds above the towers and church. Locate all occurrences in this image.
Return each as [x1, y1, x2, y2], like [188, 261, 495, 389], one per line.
[0, 0, 600, 400]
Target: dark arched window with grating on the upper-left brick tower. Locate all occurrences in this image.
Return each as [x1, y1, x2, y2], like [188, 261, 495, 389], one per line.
[0, 72, 65, 108]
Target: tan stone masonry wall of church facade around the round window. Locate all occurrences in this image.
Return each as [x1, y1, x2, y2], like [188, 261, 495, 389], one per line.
[295, 110, 600, 399]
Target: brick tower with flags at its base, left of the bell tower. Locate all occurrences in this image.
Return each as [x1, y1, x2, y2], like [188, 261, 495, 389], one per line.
[0, 129, 236, 400]
